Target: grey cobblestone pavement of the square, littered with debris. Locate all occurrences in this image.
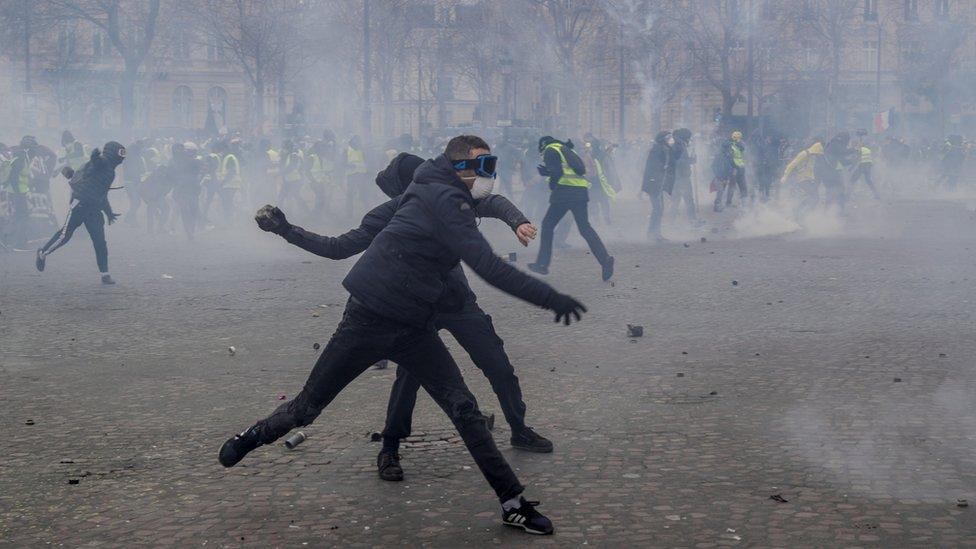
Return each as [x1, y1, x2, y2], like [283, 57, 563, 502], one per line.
[0, 196, 976, 547]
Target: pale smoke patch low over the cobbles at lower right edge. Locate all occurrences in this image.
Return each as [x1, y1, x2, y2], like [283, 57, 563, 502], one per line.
[778, 382, 976, 501]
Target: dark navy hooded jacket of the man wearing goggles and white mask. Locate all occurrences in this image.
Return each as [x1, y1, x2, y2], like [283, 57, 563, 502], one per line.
[342, 155, 555, 327]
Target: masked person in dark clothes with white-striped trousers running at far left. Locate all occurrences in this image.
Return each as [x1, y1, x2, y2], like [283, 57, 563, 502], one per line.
[34, 141, 126, 284]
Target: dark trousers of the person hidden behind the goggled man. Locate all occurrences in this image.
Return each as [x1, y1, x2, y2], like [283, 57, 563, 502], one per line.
[383, 300, 525, 439]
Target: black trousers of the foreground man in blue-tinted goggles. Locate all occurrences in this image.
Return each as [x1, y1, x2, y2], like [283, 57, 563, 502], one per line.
[256, 299, 524, 501]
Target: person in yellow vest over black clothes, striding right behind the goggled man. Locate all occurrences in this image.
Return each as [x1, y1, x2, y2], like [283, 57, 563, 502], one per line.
[528, 135, 613, 280]
